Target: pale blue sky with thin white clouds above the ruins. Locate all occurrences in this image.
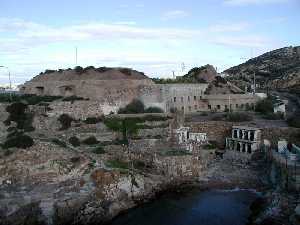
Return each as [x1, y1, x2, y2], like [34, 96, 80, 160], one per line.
[0, 0, 300, 84]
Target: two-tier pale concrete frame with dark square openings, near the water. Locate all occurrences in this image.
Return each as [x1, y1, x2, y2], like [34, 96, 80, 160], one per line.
[226, 126, 261, 154]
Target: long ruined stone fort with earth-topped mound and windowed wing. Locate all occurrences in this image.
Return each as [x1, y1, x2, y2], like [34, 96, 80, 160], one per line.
[20, 67, 259, 113]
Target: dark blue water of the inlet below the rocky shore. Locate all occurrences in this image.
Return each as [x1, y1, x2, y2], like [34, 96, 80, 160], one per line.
[111, 190, 257, 225]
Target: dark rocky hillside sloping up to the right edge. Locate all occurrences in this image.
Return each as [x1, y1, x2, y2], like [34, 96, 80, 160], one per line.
[224, 46, 300, 93]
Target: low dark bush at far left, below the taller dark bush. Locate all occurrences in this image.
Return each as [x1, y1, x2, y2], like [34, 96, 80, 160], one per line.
[2, 133, 34, 149]
